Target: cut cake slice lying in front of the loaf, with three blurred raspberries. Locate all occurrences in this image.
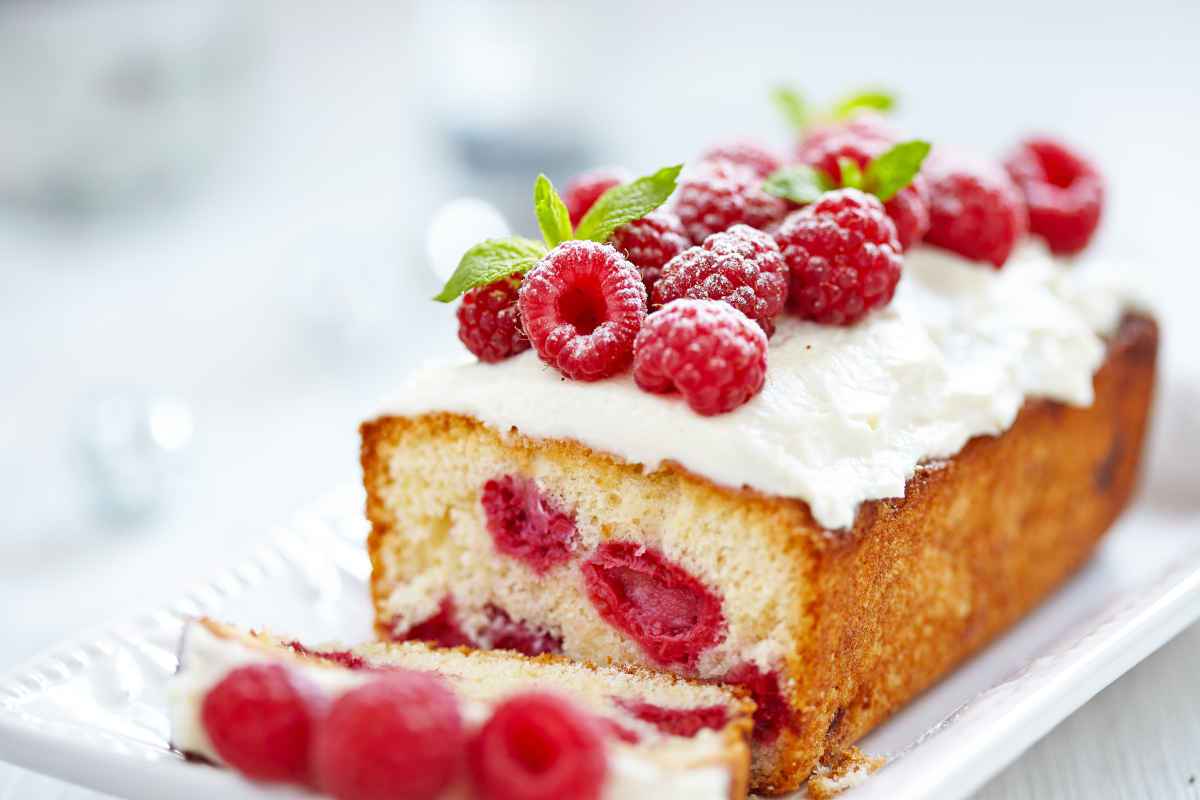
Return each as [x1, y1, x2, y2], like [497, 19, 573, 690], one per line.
[168, 619, 754, 800]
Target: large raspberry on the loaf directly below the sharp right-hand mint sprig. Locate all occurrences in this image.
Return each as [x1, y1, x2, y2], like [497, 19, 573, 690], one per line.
[776, 188, 901, 325]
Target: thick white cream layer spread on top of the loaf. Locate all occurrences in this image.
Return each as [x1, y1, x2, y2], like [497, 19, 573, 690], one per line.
[384, 241, 1128, 529]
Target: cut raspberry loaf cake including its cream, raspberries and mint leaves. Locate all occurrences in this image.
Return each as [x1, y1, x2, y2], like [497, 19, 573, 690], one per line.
[361, 121, 1158, 794]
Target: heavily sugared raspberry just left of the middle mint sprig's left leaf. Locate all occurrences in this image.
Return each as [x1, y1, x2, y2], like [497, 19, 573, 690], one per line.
[674, 161, 788, 245]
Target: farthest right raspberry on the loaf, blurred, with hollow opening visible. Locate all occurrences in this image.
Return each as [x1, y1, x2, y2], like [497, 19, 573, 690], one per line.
[1004, 137, 1104, 255]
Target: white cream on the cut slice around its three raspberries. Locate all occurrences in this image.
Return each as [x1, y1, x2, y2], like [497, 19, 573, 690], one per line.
[167, 624, 730, 800]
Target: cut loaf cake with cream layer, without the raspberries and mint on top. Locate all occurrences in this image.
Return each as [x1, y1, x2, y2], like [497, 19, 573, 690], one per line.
[361, 246, 1158, 794]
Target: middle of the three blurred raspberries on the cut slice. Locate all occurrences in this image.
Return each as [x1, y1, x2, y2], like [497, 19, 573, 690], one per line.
[313, 670, 467, 800]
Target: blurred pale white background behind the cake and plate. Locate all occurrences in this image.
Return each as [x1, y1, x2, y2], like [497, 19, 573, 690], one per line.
[0, 0, 1200, 796]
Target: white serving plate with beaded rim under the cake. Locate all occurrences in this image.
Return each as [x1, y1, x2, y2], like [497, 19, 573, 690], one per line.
[0, 479, 1200, 800]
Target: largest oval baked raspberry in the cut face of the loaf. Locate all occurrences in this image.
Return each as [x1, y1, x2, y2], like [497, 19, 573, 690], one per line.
[580, 542, 720, 668]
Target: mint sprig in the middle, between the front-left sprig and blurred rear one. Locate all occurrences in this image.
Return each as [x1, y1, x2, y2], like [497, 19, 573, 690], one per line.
[762, 139, 930, 205]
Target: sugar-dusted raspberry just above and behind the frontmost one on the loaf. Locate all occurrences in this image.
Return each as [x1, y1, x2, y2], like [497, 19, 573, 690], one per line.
[654, 225, 787, 336]
